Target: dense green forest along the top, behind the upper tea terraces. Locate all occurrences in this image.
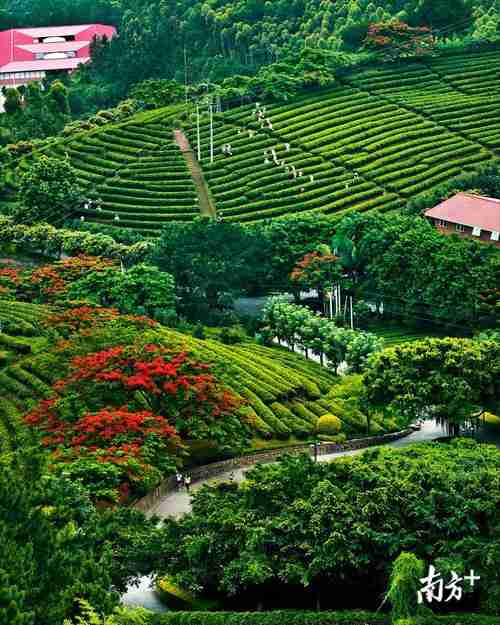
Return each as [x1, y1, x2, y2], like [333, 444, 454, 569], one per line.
[0, 0, 500, 102]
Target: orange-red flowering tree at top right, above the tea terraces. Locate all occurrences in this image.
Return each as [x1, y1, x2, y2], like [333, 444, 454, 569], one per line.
[365, 21, 434, 58]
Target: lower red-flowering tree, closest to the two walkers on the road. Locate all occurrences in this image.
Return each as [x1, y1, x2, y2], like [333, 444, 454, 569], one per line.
[25, 399, 181, 500]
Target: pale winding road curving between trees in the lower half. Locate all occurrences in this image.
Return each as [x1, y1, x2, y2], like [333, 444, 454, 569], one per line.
[122, 421, 446, 612]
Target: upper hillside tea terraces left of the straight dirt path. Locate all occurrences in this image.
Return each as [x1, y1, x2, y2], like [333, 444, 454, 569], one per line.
[13, 109, 200, 235]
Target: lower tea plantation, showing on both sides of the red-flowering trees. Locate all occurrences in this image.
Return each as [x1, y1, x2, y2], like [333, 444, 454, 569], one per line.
[0, 302, 401, 449]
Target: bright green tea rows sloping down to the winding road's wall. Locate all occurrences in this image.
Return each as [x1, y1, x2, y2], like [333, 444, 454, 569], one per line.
[156, 331, 398, 439]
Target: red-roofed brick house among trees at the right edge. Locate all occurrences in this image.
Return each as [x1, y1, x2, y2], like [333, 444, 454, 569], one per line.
[424, 193, 500, 247]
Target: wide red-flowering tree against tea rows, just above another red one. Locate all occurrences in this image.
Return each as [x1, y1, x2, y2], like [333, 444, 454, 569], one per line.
[54, 344, 241, 438]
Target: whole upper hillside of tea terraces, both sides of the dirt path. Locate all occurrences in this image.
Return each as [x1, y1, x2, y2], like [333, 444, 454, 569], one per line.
[1, 51, 500, 234]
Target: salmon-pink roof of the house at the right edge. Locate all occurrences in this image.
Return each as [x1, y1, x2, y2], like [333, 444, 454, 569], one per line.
[425, 193, 500, 232]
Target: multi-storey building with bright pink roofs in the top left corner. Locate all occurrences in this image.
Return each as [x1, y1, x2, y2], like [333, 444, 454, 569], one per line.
[0, 24, 116, 110]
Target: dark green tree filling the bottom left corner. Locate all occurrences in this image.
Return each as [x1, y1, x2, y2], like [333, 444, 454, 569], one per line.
[0, 456, 117, 625]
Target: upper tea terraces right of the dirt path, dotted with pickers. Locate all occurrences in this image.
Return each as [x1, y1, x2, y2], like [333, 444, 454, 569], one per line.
[191, 51, 500, 222]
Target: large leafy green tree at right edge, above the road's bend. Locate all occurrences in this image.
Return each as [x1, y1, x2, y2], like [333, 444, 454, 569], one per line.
[365, 338, 500, 432]
